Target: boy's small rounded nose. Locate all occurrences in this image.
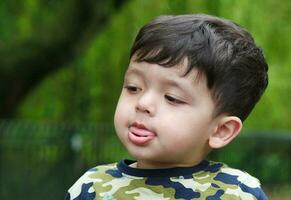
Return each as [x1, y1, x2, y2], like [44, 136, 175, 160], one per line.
[135, 92, 156, 116]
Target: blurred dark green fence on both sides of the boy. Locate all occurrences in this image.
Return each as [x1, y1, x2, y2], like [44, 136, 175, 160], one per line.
[0, 120, 291, 200]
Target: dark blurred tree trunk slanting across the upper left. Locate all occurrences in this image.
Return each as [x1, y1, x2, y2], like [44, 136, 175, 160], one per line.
[0, 0, 126, 119]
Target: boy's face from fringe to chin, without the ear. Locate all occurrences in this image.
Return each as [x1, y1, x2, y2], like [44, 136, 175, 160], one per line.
[114, 58, 219, 168]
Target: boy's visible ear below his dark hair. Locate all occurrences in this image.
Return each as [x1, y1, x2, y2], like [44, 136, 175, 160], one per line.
[209, 116, 242, 149]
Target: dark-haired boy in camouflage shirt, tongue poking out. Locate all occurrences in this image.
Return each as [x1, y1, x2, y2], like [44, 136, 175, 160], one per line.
[66, 14, 268, 200]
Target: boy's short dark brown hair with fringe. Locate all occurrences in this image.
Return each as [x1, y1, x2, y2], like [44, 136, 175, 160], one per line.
[130, 14, 268, 121]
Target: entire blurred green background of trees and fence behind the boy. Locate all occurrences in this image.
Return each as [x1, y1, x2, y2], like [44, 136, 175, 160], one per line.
[0, 0, 291, 200]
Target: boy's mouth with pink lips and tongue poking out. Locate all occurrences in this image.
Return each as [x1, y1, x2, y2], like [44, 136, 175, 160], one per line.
[128, 126, 156, 146]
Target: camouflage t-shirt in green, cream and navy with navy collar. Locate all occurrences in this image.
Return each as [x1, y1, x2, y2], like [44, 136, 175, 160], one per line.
[66, 160, 267, 200]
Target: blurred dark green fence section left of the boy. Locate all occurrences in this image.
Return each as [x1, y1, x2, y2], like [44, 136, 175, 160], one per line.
[0, 121, 127, 200]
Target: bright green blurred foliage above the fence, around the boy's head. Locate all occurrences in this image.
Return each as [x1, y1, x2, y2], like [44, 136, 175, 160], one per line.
[0, 0, 291, 129]
